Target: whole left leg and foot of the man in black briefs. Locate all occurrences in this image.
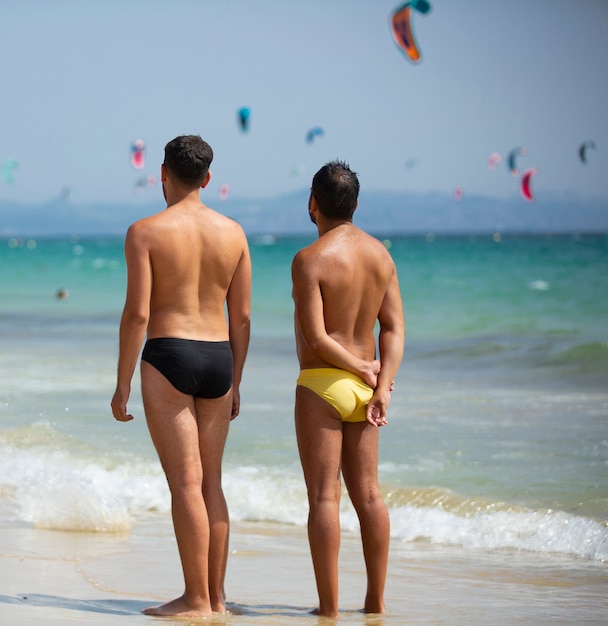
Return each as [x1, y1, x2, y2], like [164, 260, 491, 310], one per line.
[141, 361, 212, 617]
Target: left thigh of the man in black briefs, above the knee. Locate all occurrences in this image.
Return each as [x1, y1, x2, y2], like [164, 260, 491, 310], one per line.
[141, 361, 202, 486]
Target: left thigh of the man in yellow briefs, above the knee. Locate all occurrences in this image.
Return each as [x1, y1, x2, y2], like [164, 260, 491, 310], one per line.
[295, 386, 342, 495]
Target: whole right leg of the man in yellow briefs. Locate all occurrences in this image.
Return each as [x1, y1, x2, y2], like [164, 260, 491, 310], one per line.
[342, 422, 390, 613]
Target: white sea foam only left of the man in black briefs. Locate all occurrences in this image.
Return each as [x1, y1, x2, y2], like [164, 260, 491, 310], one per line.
[0, 423, 168, 532]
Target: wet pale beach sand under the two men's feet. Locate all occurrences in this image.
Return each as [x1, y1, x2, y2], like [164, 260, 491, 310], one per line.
[0, 516, 608, 626]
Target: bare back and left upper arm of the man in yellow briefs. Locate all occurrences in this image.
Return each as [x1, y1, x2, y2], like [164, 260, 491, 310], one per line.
[293, 223, 395, 368]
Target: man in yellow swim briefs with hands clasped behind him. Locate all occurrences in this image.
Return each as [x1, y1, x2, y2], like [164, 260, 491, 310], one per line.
[292, 161, 405, 618]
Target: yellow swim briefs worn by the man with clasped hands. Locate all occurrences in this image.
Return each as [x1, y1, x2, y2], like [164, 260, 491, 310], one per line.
[296, 367, 374, 422]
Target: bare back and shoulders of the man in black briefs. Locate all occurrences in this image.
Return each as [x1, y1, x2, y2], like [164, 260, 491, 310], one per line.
[127, 201, 250, 341]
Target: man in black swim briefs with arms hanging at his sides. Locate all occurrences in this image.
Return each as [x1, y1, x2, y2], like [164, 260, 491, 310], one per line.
[111, 135, 251, 617]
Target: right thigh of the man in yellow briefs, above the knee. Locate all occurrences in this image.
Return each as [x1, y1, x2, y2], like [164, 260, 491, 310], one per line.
[342, 422, 379, 502]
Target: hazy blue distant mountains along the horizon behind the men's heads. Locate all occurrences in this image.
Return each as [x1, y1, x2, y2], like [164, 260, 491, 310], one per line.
[0, 190, 608, 237]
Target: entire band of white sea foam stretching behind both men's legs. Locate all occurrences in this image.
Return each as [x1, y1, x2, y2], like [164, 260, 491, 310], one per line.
[0, 432, 608, 561]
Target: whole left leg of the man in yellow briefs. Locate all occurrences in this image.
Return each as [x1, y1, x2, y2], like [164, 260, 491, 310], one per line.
[295, 386, 342, 618]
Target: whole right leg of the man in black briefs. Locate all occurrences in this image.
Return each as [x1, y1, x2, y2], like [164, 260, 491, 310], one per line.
[195, 392, 232, 612]
